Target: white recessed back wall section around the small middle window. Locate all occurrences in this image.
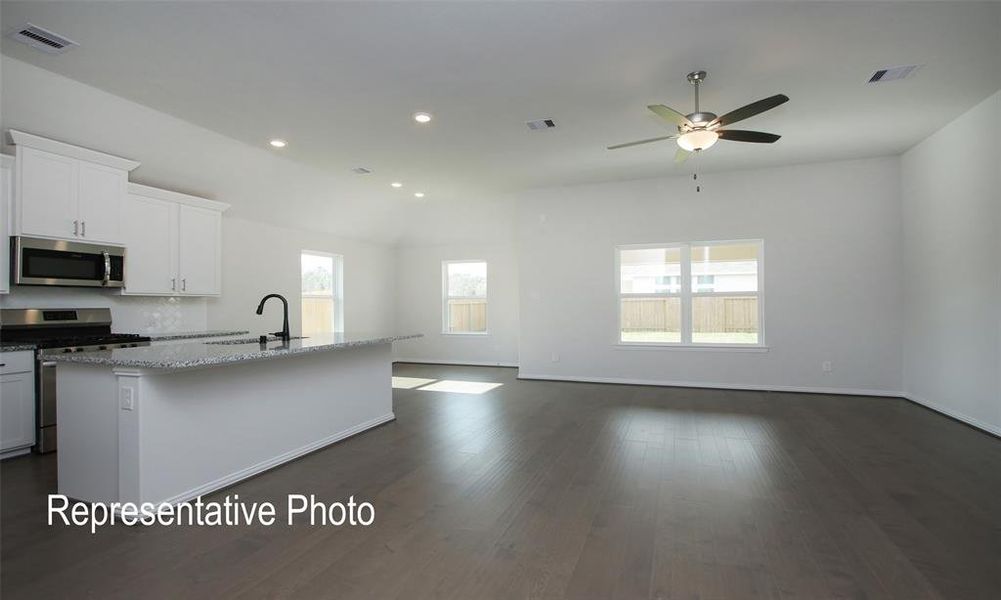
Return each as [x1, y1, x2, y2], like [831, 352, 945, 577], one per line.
[394, 242, 519, 366]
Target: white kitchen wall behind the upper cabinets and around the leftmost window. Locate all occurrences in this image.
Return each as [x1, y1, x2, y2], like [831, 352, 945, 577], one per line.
[0, 56, 395, 332]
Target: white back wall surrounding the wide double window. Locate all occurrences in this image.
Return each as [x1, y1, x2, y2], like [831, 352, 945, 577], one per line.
[518, 157, 901, 393]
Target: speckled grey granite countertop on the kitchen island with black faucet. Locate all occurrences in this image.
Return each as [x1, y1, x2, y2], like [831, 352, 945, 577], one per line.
[43, 334, 422, 371]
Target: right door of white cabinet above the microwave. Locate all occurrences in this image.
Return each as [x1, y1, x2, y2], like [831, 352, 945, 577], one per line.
[77, 161, 127, 243]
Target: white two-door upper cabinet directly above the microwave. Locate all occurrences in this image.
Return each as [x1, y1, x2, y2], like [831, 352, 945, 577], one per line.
[10, 129, 139, 243]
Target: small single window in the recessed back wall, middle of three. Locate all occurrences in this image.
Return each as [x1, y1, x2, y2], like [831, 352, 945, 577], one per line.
[441, 260, 486, 335]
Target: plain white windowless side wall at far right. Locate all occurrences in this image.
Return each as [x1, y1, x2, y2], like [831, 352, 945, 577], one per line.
[901, 92, 1001, 435]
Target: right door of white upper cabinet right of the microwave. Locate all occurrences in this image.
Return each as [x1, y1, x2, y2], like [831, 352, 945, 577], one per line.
[177, 205, 222, 295]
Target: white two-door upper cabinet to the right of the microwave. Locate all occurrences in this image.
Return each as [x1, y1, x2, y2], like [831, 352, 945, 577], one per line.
[122, 183, 229, 295]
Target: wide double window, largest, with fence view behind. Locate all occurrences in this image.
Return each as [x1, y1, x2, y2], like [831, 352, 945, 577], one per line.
[616, 240, 763, 346]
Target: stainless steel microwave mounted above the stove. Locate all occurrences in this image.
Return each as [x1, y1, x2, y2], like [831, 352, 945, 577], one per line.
[11, 236, 125, 287]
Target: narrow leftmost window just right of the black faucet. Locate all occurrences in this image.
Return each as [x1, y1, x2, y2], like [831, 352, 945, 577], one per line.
[299, 250, 344, 336]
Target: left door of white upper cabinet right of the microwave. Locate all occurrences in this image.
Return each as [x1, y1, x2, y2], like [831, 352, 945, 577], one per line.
[122, 194, 179, 295]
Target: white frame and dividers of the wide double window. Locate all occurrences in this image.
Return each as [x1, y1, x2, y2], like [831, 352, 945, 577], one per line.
[614, 239, 768, 352]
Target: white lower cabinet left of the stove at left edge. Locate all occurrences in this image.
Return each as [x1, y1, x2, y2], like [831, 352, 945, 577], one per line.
[0, 351, 35, 457]
